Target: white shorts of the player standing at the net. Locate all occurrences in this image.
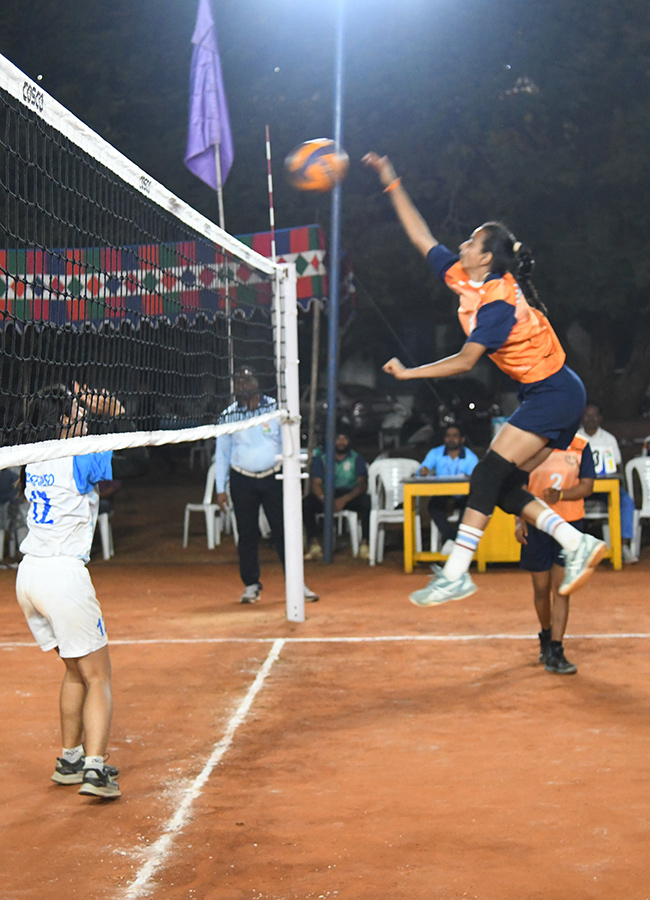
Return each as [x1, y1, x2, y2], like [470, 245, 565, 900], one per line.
[16, 556, 108, 659]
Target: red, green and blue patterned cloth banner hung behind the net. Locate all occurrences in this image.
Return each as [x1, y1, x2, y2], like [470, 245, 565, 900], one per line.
[0, 225, 327, 325]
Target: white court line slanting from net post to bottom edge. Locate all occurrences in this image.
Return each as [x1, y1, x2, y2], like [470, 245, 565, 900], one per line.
[124, 638, 285, 900]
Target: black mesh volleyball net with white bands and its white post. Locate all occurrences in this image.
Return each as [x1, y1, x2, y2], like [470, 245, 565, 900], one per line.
[0, 56, 304, 621]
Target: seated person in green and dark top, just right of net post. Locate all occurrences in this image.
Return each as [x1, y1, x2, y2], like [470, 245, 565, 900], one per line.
[302, 428, 370, 560]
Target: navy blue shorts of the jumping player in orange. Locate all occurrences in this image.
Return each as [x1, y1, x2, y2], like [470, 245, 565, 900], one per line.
[508, 366, 587, 450]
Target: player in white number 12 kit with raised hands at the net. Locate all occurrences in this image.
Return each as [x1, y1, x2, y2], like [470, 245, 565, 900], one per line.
[16, 385, 123, 799]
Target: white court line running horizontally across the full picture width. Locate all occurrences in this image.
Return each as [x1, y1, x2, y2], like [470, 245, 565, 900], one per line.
[0, 632, 650, 650]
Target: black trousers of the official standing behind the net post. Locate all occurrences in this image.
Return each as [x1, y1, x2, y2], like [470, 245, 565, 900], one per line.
[230, 469, 284, 586]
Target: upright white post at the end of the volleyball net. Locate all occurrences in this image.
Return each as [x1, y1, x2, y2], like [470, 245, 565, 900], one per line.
[278, 264, 305, 622]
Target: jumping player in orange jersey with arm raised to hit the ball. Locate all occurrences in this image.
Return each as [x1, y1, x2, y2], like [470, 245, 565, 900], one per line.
[363, 153, 605, 606]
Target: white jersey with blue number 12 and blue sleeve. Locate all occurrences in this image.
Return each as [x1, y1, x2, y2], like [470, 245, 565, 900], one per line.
[20, 451, 113, 562]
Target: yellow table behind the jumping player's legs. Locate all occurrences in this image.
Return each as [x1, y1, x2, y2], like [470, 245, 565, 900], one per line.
[404, 478, 623, 573]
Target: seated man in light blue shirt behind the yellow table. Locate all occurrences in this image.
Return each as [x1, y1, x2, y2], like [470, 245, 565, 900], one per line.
[417, 425, 478, 553]
